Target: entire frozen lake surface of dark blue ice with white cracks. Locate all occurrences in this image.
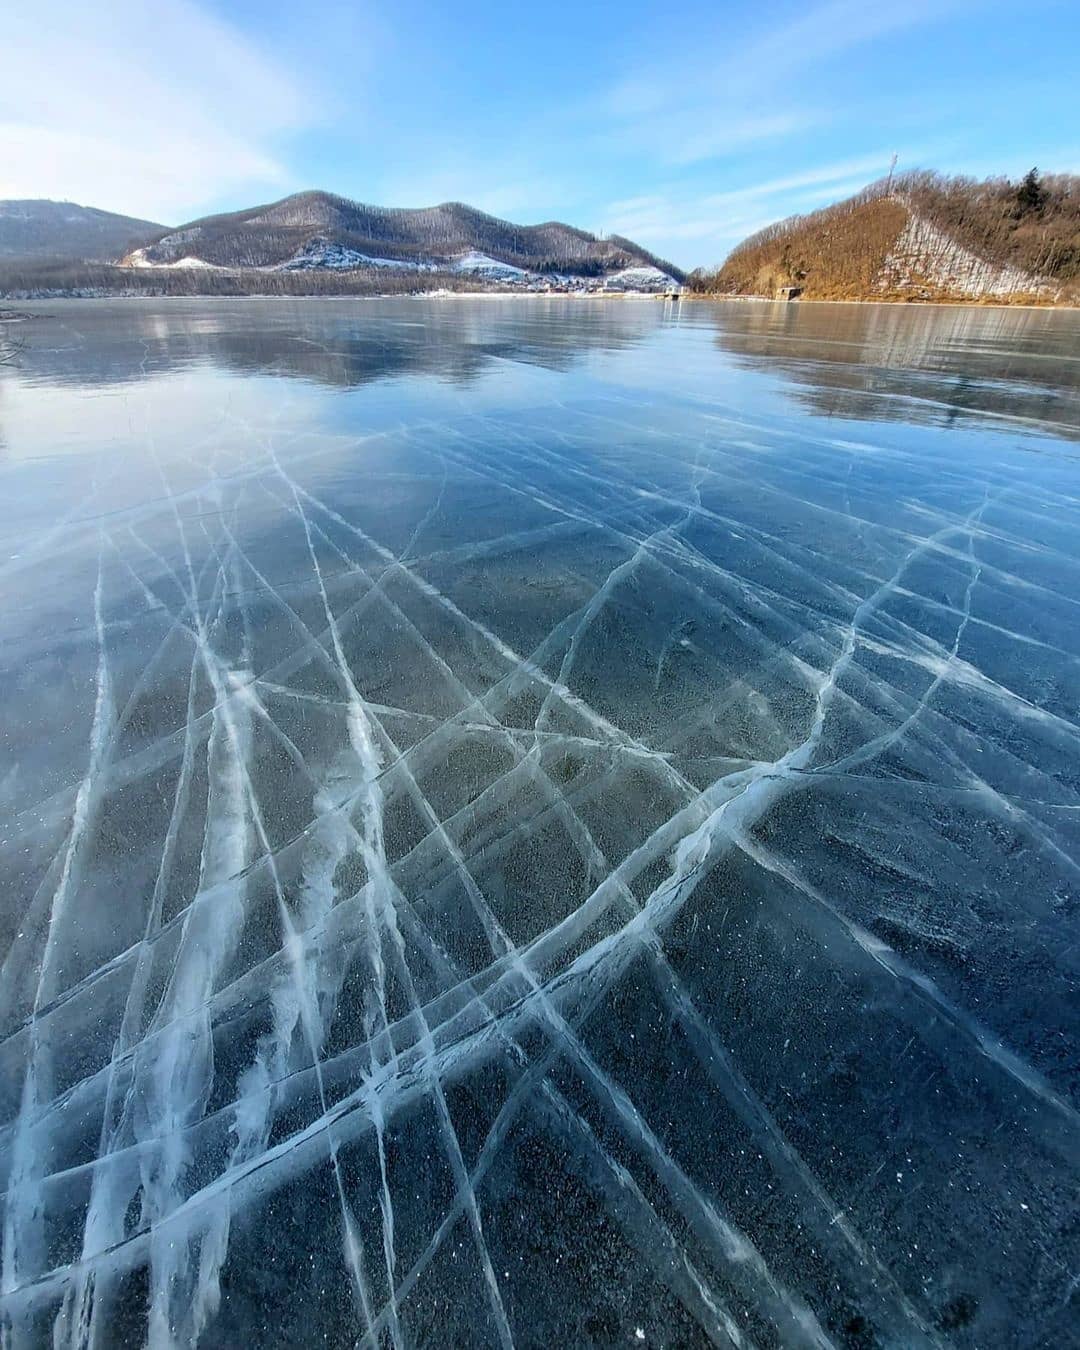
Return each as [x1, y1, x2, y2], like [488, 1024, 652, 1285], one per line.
[0, 298, 1080, 1350]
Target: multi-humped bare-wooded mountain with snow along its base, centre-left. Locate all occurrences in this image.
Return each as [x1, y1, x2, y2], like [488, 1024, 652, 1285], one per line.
[123, 192, 682, 285]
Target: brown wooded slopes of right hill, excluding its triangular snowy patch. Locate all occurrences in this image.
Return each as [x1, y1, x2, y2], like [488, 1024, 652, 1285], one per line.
[689, 169, 1080, 300]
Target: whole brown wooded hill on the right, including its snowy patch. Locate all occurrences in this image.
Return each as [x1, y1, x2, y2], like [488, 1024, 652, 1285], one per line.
[690, 169, 1080, 304]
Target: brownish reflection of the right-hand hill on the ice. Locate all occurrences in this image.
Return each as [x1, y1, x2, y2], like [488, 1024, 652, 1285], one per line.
[717, 304, 1080, 436]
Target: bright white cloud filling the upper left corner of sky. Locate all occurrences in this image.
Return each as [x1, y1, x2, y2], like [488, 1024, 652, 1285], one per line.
[0, 0, 313, 224]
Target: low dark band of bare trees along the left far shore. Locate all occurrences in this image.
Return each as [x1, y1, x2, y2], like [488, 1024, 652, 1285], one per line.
[0, 259, 513, 300]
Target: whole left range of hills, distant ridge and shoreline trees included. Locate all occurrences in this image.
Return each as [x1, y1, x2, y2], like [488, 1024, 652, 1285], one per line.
[0, 192, 683, 298]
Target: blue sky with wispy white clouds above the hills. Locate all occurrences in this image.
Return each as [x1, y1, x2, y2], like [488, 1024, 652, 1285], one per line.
[0, 0, 1080, 267]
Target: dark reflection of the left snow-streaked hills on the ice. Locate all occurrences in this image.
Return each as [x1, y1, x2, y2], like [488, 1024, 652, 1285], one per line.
[12, 297, 660, 389]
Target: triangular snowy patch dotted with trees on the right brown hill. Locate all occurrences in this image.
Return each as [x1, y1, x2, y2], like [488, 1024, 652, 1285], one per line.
[876, 211, 1057, 298]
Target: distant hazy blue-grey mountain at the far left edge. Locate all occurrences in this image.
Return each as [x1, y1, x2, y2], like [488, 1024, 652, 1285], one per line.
[0, 200, 166, 262]
